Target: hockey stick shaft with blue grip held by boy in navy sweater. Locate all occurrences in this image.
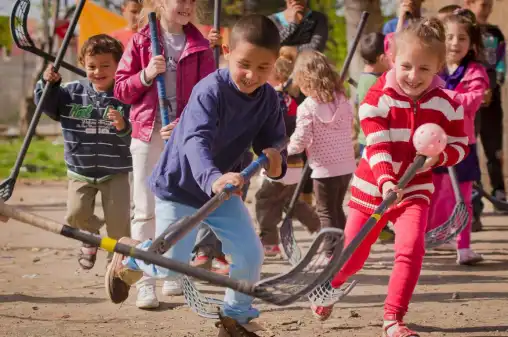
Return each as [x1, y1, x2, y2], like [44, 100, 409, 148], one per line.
[148, 139, 289, 254]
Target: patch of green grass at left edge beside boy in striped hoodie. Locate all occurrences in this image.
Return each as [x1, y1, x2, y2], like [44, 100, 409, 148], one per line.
[0, 139, 67, 180]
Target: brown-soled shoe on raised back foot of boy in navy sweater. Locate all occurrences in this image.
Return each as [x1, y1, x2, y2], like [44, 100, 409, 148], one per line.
[104, 237, 143, 304]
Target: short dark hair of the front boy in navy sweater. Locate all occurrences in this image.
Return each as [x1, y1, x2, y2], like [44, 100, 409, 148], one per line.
[229, 14, 280, 55]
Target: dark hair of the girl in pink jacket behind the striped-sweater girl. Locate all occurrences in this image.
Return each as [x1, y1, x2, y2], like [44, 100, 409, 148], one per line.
[445, 8, 483, 62]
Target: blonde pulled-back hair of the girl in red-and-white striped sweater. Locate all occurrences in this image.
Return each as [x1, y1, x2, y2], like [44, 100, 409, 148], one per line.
[395, 18, 446, 63]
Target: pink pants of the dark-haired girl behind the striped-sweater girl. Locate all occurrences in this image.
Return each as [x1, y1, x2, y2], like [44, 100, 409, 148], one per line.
[427, 174, 473, 249]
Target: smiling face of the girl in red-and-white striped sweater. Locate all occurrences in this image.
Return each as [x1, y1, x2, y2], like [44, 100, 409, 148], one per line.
[394, 41, 441, 100]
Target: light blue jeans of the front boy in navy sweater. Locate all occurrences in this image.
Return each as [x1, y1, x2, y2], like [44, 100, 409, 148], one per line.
[124, 196, 264, 324]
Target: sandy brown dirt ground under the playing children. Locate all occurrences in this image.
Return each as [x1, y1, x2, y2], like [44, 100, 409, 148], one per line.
[0, 177, 508, 337]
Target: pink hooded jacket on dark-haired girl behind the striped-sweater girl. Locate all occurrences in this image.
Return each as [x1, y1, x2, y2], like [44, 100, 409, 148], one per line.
[445, 62, 489, 144]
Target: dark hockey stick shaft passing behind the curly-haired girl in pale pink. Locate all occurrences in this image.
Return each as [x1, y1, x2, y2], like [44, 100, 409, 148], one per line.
[286, 12, 370, 218]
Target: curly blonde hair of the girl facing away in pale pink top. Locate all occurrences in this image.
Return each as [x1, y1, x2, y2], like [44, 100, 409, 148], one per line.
[294, 50, 342, 103]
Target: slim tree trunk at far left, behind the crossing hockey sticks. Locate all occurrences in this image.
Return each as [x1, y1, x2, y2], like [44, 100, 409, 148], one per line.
[19, 0, 52, 137]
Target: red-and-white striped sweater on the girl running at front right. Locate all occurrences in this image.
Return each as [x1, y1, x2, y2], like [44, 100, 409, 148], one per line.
[349, 70, 469, 213]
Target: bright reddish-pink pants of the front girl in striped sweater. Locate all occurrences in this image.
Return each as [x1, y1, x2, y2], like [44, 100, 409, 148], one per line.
[332, 201, 429, 320]
